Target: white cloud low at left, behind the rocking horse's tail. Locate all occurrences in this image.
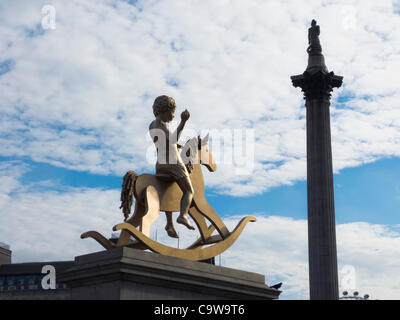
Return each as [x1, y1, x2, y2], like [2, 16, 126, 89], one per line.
[0, 162, 122, 262]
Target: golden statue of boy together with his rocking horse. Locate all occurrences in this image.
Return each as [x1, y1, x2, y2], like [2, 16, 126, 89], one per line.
[81, 96, 256, 261]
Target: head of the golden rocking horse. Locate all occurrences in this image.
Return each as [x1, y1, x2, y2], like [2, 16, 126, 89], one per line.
[181, 134, 217, 172]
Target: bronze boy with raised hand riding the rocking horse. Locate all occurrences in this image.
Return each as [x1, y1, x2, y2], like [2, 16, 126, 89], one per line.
[149, 96, 194, 238]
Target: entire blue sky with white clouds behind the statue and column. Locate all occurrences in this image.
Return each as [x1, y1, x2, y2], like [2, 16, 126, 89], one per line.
[0, 0, 400, 299]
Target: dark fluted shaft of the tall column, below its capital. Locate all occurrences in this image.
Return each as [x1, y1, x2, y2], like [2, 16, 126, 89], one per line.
[306, 99, 339, 300]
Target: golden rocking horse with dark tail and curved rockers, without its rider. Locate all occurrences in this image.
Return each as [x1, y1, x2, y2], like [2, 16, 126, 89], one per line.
[81, 135, 256, 261]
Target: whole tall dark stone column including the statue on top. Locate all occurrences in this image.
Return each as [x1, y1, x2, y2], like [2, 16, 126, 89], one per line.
[291, 20, 343, 300]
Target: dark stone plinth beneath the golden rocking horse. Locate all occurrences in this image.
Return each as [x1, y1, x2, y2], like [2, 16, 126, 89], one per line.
[58, 247, 281, 300]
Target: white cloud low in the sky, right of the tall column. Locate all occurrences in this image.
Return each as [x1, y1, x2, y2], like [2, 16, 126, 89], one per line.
[337, 222, 400, 300]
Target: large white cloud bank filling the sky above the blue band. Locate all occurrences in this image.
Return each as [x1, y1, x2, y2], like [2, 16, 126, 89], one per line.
[0, 0, 400, 195]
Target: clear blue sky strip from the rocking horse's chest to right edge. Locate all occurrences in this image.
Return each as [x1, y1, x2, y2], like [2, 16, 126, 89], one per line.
[210, 158, 400, 225]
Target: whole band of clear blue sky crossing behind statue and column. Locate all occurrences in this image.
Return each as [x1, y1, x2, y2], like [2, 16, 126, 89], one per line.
[0, 157, 400, 225]
